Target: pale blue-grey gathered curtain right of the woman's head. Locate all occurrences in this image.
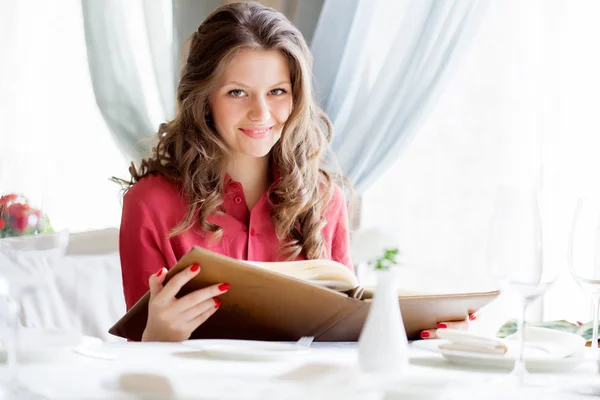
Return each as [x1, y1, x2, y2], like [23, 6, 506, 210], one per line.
[312, 0, 487, 192]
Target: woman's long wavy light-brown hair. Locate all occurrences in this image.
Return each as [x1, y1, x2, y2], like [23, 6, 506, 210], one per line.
[120, 2, 347, 259]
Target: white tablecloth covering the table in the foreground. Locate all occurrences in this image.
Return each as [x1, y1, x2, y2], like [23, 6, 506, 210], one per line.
[0, 343, 600, 400]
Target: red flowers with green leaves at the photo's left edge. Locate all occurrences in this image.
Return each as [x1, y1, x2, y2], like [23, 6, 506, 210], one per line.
[0, 193, 54, 238]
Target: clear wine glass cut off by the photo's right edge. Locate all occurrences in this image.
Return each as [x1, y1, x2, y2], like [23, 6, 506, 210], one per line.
[568, 196, 600, 360]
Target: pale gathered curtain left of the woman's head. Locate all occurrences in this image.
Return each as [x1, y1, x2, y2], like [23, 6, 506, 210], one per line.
[82, 0, 173, 159]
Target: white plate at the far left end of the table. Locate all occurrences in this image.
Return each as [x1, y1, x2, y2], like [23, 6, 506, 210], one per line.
[0, 328, 102, 362]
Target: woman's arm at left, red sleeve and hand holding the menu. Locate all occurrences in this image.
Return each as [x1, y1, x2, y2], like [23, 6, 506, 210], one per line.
[119, 184, 229, 342]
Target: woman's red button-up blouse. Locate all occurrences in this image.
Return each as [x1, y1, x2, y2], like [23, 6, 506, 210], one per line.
[119, 174, 352, 309]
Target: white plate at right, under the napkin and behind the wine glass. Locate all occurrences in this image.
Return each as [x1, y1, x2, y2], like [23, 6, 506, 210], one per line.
[412, 339, 585, 372]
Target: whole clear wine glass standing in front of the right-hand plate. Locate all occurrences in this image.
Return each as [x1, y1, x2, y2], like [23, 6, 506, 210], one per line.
[432, 186, 558, 400]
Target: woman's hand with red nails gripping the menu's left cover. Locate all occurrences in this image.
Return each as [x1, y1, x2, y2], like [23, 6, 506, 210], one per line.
[142, 264, 229, 342]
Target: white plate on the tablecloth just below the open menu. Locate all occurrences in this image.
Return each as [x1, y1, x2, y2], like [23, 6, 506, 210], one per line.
[183, 339, 309, 361]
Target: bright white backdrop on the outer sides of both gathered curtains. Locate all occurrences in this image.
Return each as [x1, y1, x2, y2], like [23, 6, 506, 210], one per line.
[0, 0, 600, 328]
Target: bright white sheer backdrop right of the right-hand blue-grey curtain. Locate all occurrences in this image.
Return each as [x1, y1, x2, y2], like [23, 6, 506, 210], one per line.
[363, 0, 600, 332]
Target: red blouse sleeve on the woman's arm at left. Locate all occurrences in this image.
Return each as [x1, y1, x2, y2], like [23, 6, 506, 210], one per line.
[119, 191, 167, 310]
